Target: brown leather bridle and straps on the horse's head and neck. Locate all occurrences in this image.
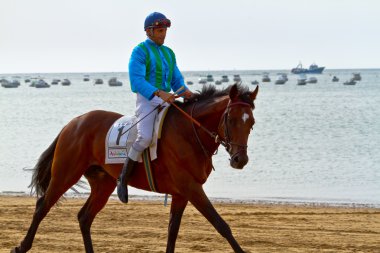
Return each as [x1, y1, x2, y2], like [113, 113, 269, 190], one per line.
[191, 100, 252, 159]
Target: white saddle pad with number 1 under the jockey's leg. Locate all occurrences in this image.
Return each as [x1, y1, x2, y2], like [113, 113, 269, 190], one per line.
[105, 106, 169, 164]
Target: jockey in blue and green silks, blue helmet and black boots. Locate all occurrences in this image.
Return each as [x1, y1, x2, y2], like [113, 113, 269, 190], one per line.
[117, 12, 193, 203]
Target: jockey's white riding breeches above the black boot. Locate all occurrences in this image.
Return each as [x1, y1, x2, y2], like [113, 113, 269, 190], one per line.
[128, 93, 168, 161]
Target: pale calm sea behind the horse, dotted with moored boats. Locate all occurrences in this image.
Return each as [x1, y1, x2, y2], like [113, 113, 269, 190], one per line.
[0, 69, 380, 208]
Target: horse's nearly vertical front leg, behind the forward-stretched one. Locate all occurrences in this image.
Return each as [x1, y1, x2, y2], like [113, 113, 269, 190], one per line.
[166, 195, 188, 253]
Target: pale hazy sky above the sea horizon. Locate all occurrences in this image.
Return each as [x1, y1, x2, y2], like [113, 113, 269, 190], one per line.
[0, 0, 380, 74]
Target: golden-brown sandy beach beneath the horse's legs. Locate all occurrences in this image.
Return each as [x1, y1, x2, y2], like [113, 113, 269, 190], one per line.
[0, 196, 380, 253]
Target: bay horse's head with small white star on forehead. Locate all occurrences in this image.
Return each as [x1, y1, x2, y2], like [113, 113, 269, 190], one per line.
[218, 84, 259, 169]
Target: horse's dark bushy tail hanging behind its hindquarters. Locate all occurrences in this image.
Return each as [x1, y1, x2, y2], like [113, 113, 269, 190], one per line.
[29, 134, 60, 197]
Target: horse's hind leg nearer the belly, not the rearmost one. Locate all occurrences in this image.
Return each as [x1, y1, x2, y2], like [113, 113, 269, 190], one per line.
[78, 166, 116, 253]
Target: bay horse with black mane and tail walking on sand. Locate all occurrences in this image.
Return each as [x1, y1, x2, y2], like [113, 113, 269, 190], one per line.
[11, 84, 258, 253]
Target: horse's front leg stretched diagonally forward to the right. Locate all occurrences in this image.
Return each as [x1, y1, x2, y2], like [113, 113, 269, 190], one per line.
[188, 183, 244, 253]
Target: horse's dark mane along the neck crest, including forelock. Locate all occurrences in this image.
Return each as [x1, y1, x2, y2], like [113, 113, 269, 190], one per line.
[176, 84, 254, 108]
